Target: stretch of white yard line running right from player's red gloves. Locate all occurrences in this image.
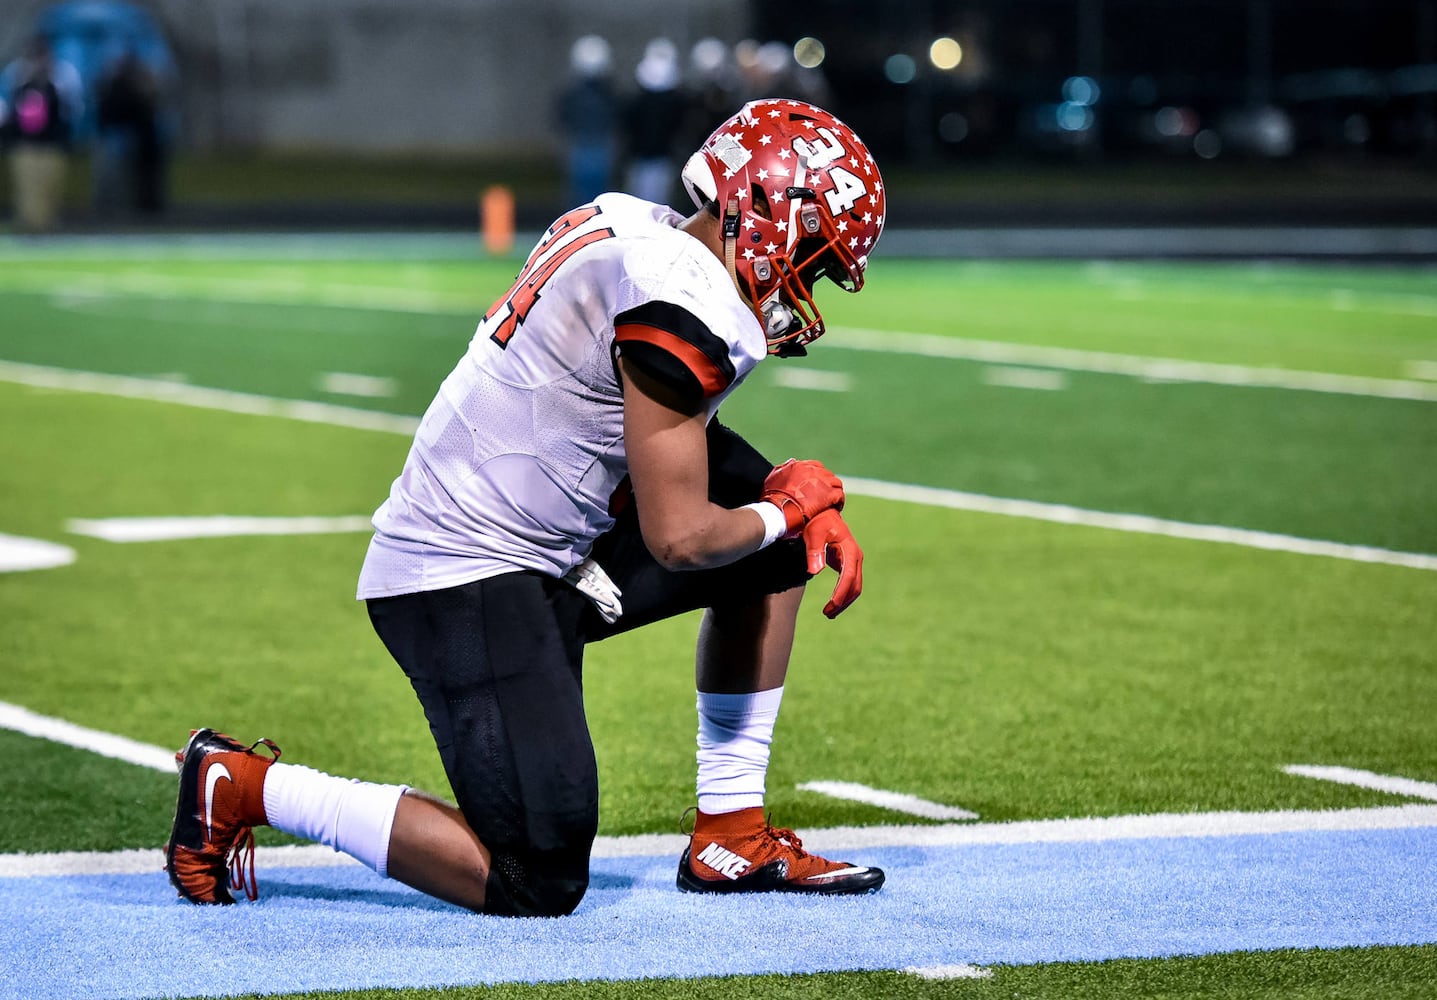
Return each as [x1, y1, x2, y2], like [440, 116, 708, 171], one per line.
[844, 476, 1437, 570]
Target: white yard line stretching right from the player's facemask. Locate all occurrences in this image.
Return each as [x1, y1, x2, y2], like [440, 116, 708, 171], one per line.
[823, 326, 1437, 402]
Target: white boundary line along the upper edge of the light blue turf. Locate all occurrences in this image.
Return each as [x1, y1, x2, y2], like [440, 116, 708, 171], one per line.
[11, 805, 1437, 878]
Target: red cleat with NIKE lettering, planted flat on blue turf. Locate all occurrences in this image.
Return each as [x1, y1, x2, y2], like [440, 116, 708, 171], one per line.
[677, 807, 884, 895]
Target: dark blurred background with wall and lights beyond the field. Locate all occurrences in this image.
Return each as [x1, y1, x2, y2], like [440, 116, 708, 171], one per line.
[0, 0, 1437, 230]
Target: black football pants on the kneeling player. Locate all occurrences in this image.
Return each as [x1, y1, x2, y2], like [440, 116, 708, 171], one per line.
[368, 421, 808, 915]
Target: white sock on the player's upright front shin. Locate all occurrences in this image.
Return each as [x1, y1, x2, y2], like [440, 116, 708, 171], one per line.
[698, 687, 783, 815]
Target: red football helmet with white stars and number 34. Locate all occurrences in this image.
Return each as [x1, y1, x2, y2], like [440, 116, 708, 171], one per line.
[683, 99, 885, 355]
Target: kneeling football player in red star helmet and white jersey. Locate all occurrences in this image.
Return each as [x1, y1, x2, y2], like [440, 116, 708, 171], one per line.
[165, 101, 885, 915]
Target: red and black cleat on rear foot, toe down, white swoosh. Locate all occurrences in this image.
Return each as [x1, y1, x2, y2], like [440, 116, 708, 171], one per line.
[165, 728, 280, 904]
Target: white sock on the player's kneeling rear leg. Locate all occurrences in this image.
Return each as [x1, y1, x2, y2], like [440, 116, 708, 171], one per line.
[264, 763, 408, 878]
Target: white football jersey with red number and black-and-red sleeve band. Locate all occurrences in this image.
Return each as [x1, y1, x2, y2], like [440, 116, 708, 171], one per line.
[359, 194, 767, 598]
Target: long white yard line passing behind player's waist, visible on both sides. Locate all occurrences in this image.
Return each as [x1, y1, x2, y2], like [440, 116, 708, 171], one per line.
[0, 363, 1437, 570]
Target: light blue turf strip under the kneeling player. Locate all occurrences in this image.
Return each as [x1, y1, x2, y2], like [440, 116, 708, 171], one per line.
[0, 828, 1437, 1000]
